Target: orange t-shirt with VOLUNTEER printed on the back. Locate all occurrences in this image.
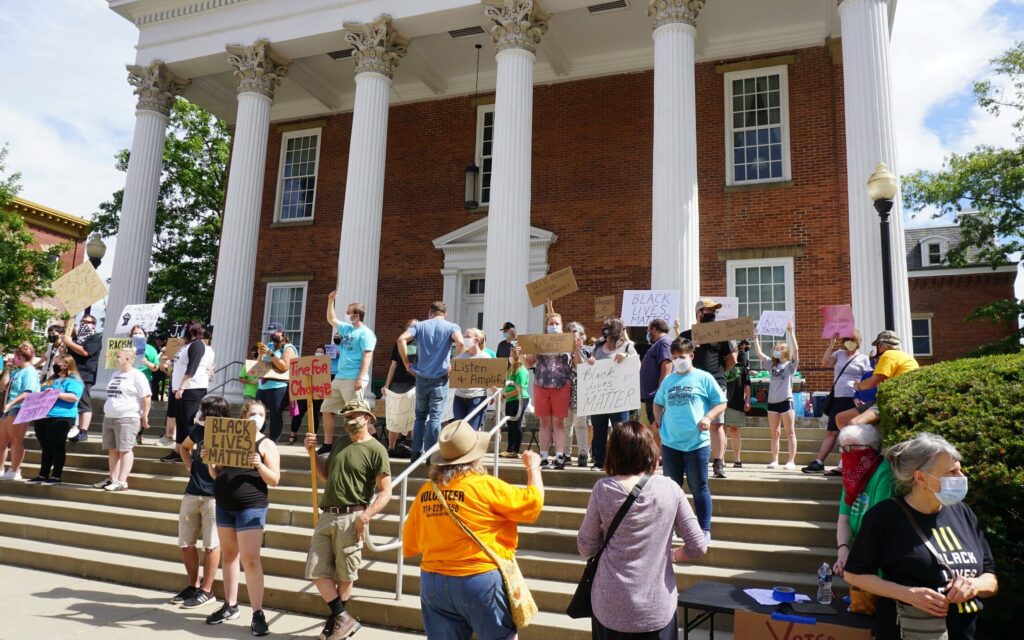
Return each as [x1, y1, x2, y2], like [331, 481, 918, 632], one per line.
[402, 473, 544, 575]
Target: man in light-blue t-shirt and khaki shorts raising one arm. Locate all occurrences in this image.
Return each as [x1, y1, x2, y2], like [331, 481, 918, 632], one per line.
[316, 291, 377, 456]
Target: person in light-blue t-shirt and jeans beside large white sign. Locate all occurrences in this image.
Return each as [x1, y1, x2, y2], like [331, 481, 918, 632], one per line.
[653, 337, 725, 542]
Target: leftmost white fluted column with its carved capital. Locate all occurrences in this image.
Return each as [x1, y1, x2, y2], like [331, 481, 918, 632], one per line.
[95, 60, 187, 395]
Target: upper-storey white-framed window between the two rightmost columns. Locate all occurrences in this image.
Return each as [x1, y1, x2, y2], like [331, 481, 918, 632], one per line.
[725, 65, 790, 184]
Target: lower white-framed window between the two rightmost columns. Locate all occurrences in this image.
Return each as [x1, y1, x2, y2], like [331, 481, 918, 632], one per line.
[726, 258, 796, 369]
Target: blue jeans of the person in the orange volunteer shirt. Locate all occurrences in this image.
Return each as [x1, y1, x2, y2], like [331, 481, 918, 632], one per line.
[420, 569, 516, 640]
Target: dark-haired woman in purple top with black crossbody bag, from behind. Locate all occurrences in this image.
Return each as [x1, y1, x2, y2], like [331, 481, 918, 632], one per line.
[577, 420, 708, 640]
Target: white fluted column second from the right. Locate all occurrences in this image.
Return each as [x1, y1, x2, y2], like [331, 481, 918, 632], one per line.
[647, 0, 702, 309]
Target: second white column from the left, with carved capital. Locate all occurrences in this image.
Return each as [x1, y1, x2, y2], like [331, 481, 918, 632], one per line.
[211, 40, 289, 398]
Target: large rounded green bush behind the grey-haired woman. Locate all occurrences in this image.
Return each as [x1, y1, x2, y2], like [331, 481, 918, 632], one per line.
[879, 353, 1024, 637]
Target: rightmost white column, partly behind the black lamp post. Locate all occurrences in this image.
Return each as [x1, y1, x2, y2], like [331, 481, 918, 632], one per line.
[839, 0, 913, 351]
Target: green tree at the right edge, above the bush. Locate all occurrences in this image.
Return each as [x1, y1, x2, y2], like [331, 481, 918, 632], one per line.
[903, 42, 1024, 354]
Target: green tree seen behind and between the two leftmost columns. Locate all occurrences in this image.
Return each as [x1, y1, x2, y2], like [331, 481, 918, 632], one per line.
[90, 98, 230, 331]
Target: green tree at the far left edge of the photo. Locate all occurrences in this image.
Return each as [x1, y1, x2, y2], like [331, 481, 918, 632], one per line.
[0, 144, 68, 350]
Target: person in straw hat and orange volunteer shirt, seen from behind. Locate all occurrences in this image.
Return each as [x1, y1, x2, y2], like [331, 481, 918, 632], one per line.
[402, 420, 544, 640]
